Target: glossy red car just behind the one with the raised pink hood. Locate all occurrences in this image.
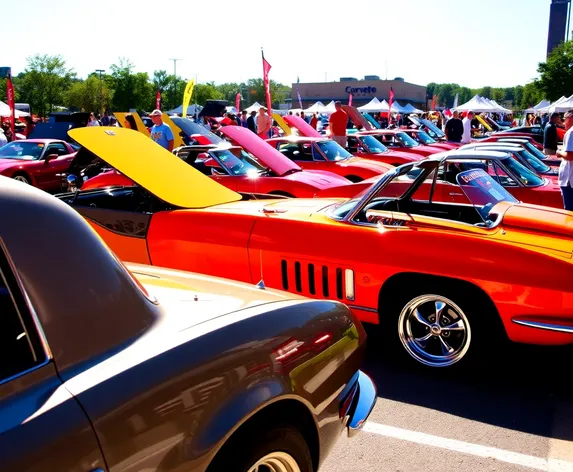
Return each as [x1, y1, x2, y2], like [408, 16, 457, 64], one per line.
[267, 136, 393, 182]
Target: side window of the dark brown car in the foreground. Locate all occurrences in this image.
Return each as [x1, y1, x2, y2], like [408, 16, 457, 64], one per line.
[0, 249, 45, 383]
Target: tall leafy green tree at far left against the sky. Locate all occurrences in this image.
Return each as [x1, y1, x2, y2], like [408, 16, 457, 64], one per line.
[17, 54, 75, 116]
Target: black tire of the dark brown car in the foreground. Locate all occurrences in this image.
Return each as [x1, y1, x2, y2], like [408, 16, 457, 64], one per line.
[207, 426, 314, 472]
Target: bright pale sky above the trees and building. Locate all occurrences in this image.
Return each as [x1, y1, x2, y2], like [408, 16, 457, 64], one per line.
[0, 0, 560, 87]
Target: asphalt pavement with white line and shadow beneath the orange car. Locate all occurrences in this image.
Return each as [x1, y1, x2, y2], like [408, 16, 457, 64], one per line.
[321, 328, 573, 472]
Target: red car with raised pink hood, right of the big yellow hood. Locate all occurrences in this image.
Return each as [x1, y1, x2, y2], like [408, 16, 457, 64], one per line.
[81, 126, 358, 197]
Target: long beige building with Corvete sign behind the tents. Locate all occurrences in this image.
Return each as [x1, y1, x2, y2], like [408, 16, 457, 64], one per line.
[291, 76, 427, 109]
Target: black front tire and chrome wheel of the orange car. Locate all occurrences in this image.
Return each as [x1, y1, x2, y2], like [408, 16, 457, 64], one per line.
[380, 282, 506, 371]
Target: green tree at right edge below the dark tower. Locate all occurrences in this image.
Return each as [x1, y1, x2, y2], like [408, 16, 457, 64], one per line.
[537, 41, 573, 101]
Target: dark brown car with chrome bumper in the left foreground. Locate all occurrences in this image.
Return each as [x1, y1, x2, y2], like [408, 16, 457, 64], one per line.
[0, 177, 376, 472]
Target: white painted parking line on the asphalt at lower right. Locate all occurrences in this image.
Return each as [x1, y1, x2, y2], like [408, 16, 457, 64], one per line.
[364, 422, 573, 472]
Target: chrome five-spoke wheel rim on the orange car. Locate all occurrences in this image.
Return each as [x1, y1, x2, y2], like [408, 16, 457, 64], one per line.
[398, 295, 471, 367]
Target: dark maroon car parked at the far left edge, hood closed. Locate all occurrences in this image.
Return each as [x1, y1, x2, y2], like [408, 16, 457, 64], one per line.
[0, 139, 77, 192]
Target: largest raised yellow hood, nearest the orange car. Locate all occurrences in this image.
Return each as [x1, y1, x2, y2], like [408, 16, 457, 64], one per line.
[68, 126, 241, 208]
